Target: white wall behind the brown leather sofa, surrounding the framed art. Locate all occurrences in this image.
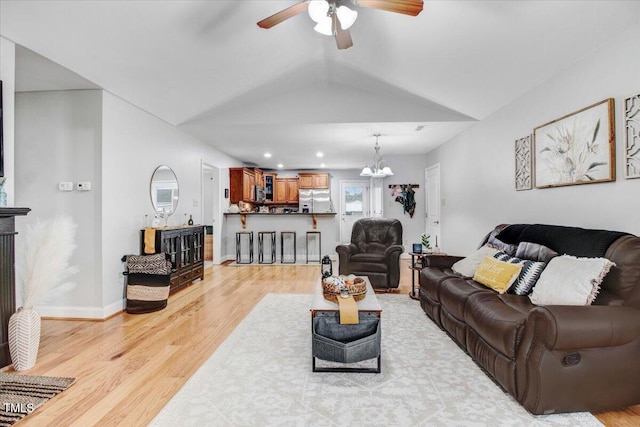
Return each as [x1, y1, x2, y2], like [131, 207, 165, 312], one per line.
[424, 25, 640, 255]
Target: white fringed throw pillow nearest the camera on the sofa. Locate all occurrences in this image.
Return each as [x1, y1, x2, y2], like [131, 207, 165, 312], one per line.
[529, 255, 615, 305]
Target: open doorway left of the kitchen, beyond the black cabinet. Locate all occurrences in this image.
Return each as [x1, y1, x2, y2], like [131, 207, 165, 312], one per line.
[201, 161, 222, 268]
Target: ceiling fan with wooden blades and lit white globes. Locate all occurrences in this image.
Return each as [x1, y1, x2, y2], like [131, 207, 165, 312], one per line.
[258, 0, 423, 49]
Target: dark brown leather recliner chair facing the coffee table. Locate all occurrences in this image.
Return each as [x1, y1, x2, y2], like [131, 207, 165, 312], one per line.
[336, 218, 404, 289]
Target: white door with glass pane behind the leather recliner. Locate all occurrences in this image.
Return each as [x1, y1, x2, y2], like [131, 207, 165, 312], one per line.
[340, 181, 369, 243]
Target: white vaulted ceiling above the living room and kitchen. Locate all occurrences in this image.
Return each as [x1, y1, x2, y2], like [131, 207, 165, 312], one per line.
[0, 0, 640, 169]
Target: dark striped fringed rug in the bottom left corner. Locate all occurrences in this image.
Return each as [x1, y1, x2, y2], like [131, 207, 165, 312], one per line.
[0, 373, 76, 426]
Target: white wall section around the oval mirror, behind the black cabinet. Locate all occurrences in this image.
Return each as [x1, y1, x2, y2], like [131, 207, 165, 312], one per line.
[101, 92, 241, 314]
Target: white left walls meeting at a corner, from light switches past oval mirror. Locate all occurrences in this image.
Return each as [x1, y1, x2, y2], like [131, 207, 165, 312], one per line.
[16, 90, 239, 318]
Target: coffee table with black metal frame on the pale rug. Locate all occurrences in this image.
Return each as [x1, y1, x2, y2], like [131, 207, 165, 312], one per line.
[310, 276, 382, 373]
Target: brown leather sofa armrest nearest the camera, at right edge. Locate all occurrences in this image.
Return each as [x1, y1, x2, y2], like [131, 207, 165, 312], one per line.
[528, 305, 640, 351]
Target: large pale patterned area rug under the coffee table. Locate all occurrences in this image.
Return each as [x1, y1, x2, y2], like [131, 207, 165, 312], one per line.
[150, 294, 601, 427]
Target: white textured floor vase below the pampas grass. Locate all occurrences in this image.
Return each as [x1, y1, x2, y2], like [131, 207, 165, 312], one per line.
[9, 307, 40, 371]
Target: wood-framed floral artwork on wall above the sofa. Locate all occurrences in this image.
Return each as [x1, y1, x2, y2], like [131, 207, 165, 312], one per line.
[533, 98, 616, 188]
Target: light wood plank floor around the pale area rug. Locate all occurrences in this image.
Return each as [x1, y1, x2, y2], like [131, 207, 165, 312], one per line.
[7, 260, 640, 427]
